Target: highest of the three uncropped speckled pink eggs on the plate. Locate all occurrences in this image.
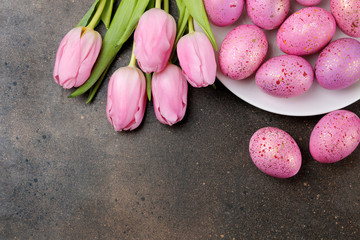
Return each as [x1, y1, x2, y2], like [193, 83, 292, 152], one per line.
[276, 7, 336, 55]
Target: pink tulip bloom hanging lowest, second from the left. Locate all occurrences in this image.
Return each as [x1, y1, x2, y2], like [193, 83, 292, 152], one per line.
[106, 66, 146, 131]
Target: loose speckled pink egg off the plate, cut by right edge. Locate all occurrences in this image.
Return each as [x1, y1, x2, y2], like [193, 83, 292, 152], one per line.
[309, 110, 360, 163]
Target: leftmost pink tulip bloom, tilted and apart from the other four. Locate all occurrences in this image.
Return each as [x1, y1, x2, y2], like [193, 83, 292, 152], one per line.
[53, 27, 102, 89]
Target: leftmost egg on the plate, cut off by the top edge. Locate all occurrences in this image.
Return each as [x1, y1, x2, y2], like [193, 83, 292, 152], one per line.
[204, 0, 244, 27]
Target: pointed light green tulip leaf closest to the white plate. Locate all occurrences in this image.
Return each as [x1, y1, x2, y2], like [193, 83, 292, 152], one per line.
[182, 0, 218, 51]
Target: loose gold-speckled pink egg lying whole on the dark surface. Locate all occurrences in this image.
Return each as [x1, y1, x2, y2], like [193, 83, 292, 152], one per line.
[249, 127, 301, 178]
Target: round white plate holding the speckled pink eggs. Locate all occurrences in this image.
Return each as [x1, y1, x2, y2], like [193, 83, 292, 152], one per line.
[195, 0, 360, 116]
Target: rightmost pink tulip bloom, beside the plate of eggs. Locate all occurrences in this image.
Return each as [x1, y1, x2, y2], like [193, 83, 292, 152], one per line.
[177, 32, 216, 87]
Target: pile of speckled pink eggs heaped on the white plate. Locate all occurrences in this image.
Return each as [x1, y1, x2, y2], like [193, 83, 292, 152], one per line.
[204, 0, 360, 95]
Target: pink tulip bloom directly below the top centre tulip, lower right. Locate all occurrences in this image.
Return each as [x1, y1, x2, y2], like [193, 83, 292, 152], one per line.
[151, 64, 188, 126]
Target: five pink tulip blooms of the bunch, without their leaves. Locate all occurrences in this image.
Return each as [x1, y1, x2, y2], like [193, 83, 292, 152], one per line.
[54, 0, 216, 131]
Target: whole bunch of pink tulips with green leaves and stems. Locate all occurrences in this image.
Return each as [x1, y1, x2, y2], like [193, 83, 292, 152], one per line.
[53, 0, 217, 131]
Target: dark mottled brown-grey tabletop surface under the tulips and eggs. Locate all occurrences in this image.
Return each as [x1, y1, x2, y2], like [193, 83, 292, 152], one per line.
[0, 0, 360, 240]
